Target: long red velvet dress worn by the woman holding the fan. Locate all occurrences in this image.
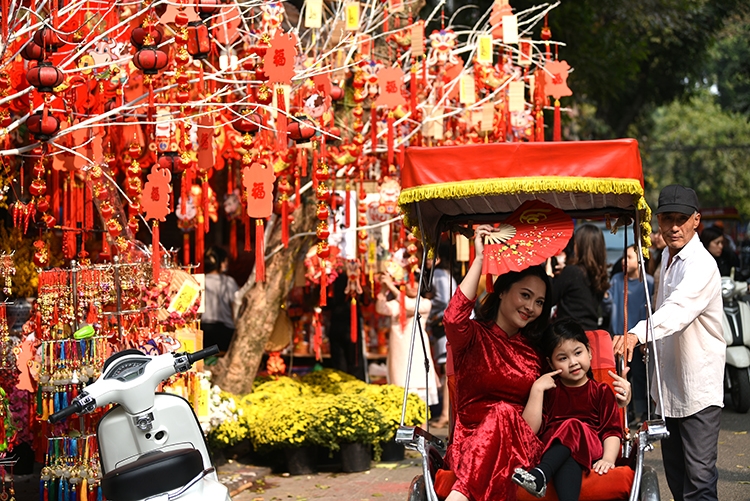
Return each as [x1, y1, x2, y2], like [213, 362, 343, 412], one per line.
[443, 289, 542, 501]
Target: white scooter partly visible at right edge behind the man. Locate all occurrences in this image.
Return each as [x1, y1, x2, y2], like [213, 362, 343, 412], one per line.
[721, 277, 750, 413]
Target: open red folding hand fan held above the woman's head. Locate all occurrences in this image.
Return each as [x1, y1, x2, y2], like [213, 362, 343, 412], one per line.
[482, 200, 573, 292]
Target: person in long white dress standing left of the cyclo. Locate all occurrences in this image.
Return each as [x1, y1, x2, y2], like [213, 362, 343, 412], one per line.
[375, 265, 438, 405]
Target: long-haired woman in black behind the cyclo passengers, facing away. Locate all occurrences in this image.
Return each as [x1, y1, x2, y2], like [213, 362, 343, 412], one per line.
[547, 224, 609, 330]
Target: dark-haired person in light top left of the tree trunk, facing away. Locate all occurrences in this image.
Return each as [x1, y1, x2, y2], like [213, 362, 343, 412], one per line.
[201, 247, 239, 354]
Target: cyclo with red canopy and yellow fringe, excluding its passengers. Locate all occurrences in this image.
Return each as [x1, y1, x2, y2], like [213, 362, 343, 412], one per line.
[396, 139, 668, 501]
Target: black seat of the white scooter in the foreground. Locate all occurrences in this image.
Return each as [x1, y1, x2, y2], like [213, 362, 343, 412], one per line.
[102, 449, 203, 501]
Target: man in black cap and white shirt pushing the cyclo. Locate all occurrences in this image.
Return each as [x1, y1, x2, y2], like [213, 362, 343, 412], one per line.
[615, 184, 726, 501]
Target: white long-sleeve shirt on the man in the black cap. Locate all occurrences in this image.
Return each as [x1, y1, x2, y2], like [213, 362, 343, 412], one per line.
[630, 234, 726, 418]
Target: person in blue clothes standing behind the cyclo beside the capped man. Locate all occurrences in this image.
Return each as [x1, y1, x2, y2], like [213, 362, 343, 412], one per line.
[609, 245, 654, 422]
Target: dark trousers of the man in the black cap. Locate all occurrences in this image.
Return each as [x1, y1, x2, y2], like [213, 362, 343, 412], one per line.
[661, 406, 721, 501]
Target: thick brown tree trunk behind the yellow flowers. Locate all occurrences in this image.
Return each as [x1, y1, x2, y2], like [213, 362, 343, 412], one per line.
[213, 201, 316, 395]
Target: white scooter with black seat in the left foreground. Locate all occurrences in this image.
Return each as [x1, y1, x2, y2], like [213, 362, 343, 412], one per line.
[49, 346, 230, 501]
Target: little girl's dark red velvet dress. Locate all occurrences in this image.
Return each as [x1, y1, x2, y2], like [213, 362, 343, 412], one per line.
[539, 379, 622, 471]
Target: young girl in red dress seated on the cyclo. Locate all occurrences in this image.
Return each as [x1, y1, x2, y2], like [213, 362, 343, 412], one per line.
[512, 319, 622, 501]
